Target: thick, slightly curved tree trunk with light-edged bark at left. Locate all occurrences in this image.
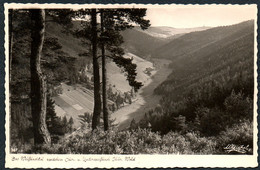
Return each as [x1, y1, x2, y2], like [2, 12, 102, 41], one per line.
[30, 9, 51, 144]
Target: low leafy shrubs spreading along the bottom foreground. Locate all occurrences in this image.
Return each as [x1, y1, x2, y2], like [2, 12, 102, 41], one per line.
[33, 128, 215, 154]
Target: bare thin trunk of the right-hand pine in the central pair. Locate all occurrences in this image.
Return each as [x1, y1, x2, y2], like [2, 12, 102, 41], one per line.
[100, 10, 109, 131]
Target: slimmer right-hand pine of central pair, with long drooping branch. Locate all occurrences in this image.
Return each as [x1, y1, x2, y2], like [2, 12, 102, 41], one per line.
[99, 9, 150, 131]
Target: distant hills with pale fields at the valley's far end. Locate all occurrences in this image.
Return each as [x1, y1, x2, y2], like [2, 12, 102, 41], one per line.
[122, 26, 209, 58]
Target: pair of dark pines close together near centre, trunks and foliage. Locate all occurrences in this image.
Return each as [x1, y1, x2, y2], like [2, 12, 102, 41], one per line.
[75, 9, 150, 130]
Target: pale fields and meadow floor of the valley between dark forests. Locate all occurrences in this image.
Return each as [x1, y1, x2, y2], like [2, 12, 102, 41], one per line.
[53, 53, 171, 129]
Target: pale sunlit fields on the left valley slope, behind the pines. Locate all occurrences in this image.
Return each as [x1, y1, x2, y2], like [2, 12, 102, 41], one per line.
[54, 53, 153, 128]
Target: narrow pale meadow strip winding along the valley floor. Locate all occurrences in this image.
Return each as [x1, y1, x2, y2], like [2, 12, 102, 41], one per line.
[111, 59, 171, 130]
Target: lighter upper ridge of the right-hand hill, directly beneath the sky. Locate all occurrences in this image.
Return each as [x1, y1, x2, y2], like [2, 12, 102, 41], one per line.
[152, 20, 254, 60]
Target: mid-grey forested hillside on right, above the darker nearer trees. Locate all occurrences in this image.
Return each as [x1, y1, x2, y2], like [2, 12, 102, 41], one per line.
[154, 21, 254, 95]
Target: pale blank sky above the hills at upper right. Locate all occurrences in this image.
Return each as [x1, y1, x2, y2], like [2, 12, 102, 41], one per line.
[146, 5, 257, 28]
